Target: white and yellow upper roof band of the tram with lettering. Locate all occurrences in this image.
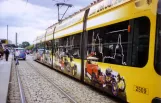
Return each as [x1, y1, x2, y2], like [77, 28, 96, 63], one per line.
[36, 0, 131, 41]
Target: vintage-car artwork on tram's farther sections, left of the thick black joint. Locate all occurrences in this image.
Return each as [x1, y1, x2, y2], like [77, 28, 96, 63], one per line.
[36, 50, 81, 79]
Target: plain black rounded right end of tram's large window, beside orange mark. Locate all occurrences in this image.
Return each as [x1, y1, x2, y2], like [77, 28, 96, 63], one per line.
[132, 17, 150, 67]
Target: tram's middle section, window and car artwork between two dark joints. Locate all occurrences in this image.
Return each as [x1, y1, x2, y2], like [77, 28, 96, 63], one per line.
[53, 33, 81, 80]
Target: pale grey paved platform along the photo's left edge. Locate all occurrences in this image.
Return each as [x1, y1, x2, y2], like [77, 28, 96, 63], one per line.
[0, 55, 12, 103]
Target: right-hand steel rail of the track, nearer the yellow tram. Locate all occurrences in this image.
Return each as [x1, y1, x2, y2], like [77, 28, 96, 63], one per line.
[26, 61, 77, 103]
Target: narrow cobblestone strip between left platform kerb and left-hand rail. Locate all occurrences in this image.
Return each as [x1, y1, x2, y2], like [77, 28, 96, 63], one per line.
[7, 62, 21, 103]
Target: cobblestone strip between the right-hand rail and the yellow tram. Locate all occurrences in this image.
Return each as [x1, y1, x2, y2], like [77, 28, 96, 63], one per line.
[28, 56, 118, 103]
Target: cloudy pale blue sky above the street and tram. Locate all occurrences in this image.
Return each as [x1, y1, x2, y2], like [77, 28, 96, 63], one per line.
[0, 0, 93, 44]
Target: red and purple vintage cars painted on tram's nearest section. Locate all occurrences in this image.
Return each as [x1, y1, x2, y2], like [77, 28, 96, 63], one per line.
[85, 56, 126, 99]
